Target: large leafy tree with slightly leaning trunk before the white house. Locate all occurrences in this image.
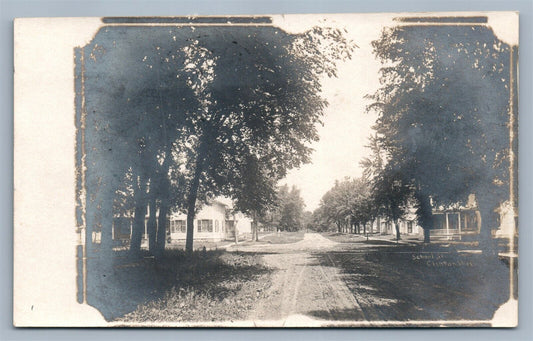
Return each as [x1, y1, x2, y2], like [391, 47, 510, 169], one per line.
[174, 27, 351, 251]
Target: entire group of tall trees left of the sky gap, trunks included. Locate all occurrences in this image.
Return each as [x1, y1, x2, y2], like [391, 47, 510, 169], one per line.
[78, 26, 352, 256]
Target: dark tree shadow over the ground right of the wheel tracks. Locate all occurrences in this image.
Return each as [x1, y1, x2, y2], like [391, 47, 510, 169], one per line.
[310, 246, 509, 321]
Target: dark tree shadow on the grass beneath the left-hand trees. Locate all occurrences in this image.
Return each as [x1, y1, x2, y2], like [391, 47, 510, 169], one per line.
[87, 250, 269, 321]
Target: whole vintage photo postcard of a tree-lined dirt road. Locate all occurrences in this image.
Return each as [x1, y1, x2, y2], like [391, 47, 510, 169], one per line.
[13, 12, 519, 327]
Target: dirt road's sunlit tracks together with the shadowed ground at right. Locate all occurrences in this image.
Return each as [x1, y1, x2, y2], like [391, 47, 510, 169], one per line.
[224, 233, 508, 327]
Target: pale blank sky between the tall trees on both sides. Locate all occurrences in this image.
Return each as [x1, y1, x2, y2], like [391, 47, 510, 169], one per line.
[275, 15, 392, 211]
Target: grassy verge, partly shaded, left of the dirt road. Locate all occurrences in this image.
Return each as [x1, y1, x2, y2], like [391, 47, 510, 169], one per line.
[89, 250, 271, 325]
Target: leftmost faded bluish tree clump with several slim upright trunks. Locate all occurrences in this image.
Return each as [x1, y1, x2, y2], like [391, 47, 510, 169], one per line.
[83, 27, 202, 254]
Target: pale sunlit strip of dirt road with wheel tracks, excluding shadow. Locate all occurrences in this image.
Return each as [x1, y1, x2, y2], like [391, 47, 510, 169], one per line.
[227, 233, 365, 327]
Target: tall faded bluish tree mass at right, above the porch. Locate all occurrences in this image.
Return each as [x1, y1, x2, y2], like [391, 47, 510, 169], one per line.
[369, 25, 510, 250]
